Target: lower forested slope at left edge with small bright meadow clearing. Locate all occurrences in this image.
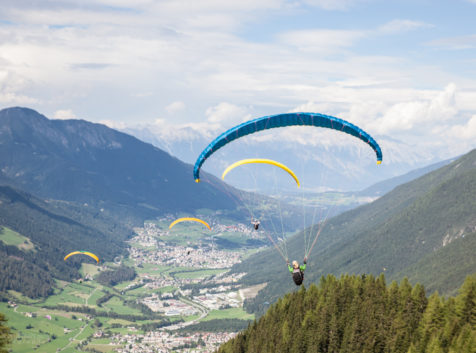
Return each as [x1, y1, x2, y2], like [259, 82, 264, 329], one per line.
[0, 186, 130, 298]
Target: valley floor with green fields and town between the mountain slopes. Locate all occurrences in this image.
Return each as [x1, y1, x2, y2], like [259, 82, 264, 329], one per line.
[0, 219, 264, 353]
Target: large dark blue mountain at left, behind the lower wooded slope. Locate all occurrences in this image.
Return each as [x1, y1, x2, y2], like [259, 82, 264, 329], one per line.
[0, 108, 237, 223]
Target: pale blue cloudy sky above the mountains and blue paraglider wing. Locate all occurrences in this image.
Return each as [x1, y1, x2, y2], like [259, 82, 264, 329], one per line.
[0, 0, 476, 164]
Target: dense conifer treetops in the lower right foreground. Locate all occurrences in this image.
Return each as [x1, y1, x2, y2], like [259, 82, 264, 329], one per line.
[219, 275, 476, 353]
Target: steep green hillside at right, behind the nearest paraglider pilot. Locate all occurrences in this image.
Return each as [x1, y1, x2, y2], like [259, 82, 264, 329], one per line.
[233, 150, 476, 311]
